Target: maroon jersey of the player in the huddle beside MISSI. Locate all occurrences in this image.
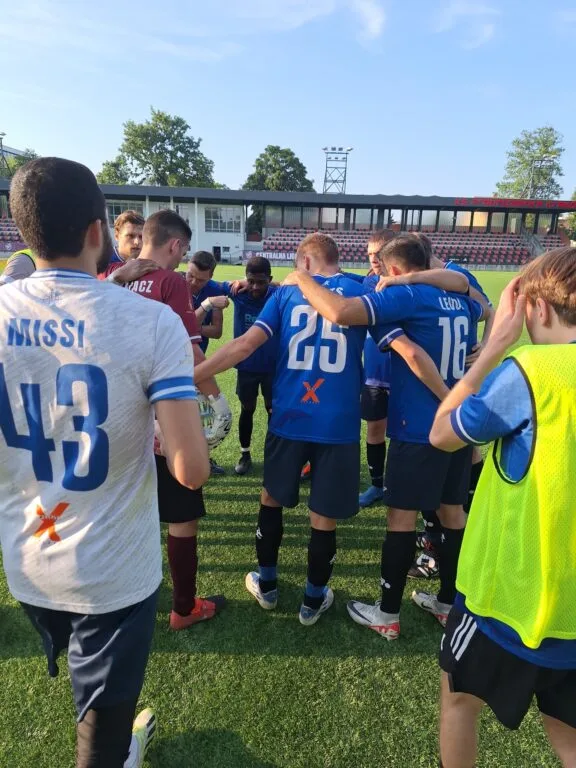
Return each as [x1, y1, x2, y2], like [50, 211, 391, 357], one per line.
[98, 263, 202, 344]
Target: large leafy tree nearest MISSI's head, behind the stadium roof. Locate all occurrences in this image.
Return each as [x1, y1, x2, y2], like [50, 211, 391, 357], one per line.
[98, 108, 215, 187]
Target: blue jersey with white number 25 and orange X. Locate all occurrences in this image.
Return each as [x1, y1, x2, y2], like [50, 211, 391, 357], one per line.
[255, 274, 384, 443]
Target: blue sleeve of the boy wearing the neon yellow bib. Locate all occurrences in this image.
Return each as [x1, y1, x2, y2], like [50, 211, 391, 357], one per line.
[450, 359, 533, 445]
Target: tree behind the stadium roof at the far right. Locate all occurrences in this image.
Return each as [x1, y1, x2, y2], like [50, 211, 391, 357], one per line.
[495, 125, 564, 200]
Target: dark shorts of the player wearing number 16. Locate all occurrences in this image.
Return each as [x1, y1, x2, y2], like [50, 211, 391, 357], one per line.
[384, 440, 472, 511]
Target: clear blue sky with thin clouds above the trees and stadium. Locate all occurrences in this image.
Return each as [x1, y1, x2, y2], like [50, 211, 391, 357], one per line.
[0, 0, 576, 198]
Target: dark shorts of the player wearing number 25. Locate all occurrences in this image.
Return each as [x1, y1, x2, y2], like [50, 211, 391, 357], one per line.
[263, 432, 360, 520]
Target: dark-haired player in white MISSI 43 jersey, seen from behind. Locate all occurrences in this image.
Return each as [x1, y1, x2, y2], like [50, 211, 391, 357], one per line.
[0, 157, 209, 768]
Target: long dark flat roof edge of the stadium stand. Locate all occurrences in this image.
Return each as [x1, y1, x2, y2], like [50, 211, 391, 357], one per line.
[0, 179, 576, 211]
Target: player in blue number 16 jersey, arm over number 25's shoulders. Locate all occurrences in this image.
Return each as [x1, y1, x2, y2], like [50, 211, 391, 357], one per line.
[289, 235, 483, 640]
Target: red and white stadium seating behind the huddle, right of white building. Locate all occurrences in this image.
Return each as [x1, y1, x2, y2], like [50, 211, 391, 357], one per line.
[263, 228, 562, 266]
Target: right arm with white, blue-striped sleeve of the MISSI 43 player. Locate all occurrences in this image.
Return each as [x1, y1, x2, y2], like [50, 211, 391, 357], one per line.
[147, 307, 210, 489]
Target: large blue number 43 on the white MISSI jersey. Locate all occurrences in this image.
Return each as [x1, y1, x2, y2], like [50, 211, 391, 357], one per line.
[0, 363, 109, 491]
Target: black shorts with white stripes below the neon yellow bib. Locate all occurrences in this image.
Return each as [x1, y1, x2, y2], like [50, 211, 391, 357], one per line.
[440, 608, 576, 729]
